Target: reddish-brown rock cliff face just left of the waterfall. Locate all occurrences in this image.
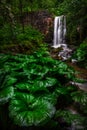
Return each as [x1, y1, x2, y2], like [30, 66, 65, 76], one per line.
[23, 11, 54, 43]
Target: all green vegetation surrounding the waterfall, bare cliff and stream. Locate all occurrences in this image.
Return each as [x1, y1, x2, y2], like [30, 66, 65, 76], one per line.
[0, 0, 87, 130]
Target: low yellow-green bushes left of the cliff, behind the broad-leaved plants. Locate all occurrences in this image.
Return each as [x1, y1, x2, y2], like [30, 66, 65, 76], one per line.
[0, 25, 43, 54]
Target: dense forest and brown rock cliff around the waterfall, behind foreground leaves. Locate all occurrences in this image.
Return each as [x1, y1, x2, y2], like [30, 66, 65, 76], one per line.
[0, 0, 87, 66]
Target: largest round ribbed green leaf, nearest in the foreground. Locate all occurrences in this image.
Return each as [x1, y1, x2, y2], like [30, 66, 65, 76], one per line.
[9, 93, 55, 126]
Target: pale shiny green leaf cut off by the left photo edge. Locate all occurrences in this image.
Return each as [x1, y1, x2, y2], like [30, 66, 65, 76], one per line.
[0, 87, 14, 104]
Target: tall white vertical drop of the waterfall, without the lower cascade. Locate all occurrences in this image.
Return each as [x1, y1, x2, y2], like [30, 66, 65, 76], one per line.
[53, 15, 66, 48]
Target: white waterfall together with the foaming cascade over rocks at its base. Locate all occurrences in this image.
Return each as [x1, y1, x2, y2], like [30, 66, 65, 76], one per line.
[53, 15, 72, 60]
